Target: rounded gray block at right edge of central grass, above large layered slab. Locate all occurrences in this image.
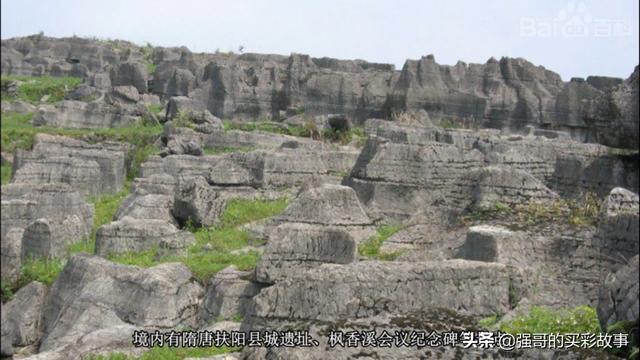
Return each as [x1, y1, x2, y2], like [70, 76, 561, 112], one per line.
[255, 223, 357, 283]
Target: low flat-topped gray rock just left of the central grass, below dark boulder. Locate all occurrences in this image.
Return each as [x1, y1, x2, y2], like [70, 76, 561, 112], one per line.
[96, 217, 196, 256]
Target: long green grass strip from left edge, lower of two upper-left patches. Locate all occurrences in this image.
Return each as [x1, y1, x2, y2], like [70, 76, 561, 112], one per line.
[1, 113, 162, 179]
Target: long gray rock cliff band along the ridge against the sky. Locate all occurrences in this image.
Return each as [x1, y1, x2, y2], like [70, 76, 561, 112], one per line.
[2, 36, 638, 148]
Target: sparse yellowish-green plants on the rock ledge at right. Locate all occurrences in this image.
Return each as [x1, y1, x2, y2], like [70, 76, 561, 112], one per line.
[460, 193, 601, 230]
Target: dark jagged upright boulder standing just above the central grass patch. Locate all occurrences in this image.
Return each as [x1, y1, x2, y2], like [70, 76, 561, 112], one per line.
[173, 177, 226, 226]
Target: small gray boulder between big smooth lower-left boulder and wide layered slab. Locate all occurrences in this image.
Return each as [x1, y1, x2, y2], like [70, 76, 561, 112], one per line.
[199, 266, 261, 326]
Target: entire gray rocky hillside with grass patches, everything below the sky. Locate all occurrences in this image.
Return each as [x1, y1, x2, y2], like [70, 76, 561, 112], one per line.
[1, 36, 640, 360]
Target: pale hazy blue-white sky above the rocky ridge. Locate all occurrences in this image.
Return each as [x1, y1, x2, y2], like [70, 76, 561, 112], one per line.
[1, 0, 638, 80]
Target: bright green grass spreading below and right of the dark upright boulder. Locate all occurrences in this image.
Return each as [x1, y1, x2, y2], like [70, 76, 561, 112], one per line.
[108, 199, 287, 281]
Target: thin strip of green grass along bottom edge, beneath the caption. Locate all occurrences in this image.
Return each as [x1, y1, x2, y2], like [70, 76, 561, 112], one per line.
[86, 346, 240, 360]
